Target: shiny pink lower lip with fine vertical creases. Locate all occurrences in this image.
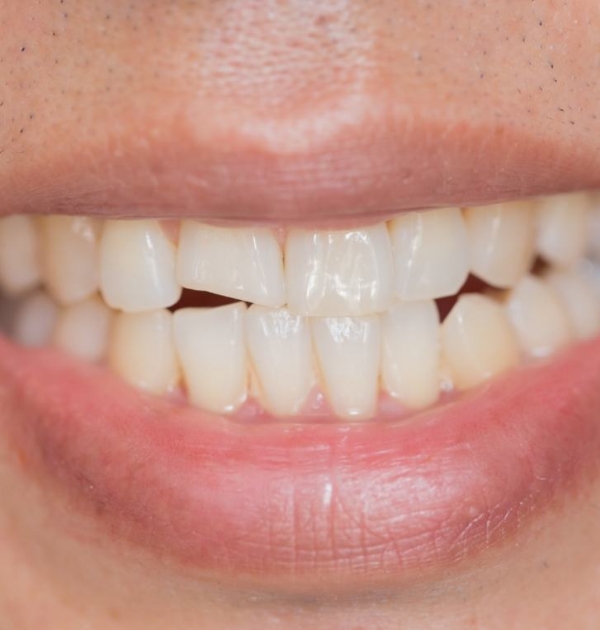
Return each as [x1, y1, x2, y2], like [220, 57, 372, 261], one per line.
[0, 339, 600, 585]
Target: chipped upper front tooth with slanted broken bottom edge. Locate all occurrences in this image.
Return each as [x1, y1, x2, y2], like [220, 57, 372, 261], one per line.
[177, 221, 285, 307]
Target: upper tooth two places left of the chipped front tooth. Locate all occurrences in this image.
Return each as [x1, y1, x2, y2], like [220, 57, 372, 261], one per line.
[41, 216, 102, 304]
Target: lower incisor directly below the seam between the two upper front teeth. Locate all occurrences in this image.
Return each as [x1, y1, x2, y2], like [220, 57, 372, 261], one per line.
[246, 305, 316, 416]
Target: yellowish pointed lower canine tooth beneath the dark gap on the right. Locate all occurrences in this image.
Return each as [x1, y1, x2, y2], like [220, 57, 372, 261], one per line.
[442, 293, 519, 389]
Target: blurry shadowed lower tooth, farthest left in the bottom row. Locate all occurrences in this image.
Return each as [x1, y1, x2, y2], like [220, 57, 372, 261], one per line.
[12, 291, 58, 348]
